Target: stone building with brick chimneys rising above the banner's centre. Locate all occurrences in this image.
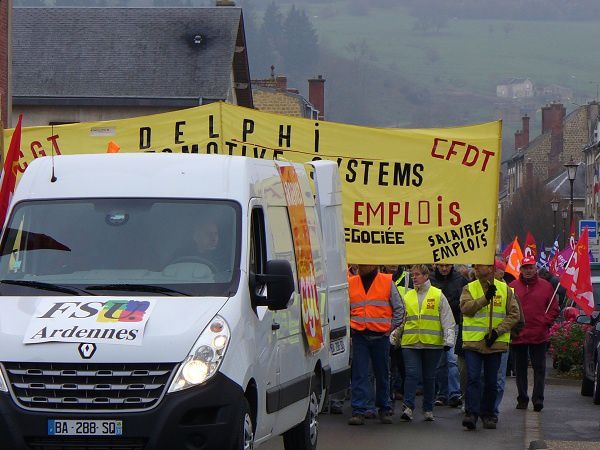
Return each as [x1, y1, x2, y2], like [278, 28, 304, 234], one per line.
[252, 66, 325, 120]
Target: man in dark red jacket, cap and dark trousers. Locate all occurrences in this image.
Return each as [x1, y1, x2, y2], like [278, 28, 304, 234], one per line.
[510, 256, 560, 411]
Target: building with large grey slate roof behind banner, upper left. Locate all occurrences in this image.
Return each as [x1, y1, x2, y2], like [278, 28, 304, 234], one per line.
[12, 6, 254, 126]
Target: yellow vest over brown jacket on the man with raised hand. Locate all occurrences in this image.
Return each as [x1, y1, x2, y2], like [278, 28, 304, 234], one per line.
[463, 280, 510, 343]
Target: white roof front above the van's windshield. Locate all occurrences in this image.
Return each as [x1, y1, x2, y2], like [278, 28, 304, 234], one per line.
[13, 153, 288, 201]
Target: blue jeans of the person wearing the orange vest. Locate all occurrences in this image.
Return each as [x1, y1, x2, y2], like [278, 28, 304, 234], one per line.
[350, 333, 392, 416]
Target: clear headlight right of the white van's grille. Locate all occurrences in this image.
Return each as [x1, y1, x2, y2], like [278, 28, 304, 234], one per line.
[169, 315, 231, 392]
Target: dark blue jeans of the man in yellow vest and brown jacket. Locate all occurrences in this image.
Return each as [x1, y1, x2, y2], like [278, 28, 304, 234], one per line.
[465, 349, 502, 417]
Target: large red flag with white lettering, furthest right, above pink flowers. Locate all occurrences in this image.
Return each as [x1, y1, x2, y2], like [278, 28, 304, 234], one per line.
[560, 227, 594, 316]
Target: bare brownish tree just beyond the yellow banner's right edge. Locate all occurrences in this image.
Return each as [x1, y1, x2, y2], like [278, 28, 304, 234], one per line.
[502, 177, 555, 246]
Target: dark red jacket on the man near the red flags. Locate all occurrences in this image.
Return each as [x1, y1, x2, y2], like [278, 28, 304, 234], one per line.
[510, 275, 560, 344]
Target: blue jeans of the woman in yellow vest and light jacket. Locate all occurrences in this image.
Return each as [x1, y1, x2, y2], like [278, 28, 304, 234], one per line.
[402, 348, 443, 411]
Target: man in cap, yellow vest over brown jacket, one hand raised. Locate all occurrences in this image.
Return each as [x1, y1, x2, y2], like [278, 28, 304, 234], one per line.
[460, 264, 519, 430]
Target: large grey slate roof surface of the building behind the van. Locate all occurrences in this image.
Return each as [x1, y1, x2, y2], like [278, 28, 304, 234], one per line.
[13, 7, 241, 99]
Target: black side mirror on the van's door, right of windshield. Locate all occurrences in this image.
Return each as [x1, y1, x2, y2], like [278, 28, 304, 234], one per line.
[256, 259, 295, 311]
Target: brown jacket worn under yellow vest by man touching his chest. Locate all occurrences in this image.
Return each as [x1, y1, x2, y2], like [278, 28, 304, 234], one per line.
[460, 278, 521, 353]
